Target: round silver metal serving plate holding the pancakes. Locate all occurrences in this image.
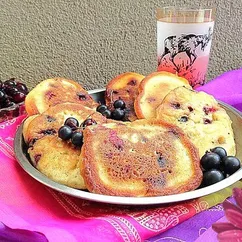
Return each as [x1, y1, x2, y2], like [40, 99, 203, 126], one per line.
[14, 89, 242, 205]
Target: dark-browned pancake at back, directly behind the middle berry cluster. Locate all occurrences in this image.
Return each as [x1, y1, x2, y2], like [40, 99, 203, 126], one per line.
[105, 72, 145, 121]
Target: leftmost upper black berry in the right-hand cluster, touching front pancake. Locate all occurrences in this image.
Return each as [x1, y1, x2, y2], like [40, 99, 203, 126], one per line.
[201, 152, 221, 171]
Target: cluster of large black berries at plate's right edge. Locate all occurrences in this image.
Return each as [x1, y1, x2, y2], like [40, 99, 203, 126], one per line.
[201, 147, 241, 187]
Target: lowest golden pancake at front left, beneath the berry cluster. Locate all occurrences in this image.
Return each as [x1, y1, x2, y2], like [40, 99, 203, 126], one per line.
[28, 136, 86, 189]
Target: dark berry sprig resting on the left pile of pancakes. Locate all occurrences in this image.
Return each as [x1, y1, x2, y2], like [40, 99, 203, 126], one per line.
[58, 117, 97, 147]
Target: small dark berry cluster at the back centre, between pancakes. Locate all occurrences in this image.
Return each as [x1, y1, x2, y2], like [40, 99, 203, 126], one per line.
[97, 99, 126, 120]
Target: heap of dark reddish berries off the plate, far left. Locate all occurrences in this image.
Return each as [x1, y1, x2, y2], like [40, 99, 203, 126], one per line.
[0, 78, 28, 108]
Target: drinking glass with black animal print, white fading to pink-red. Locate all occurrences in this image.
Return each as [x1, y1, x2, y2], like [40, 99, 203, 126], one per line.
[156, 7, 215, 87]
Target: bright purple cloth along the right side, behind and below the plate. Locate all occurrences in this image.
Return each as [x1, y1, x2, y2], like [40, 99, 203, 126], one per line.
[149, 68, 242, 242]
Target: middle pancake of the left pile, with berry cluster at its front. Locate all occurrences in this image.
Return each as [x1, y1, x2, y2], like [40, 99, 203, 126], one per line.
[24, 103, 106, 145]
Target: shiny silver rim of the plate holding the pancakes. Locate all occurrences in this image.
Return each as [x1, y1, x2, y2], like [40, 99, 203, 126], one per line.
[14, 99, 242, 205]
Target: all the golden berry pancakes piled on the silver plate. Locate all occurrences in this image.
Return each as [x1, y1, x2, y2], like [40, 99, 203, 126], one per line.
[23, 72, 235, 197]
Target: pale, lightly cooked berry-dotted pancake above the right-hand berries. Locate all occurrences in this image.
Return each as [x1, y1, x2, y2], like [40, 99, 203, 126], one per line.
[156, 87, 236, 157]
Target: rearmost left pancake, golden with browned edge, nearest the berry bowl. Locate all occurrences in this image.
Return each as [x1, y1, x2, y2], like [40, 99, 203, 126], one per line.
[25, 77, 98, 116]
